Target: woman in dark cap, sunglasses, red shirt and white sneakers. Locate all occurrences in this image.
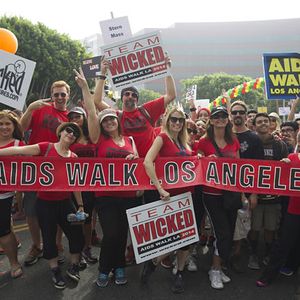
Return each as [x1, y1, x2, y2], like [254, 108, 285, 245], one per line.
[198, 106, 240, 289]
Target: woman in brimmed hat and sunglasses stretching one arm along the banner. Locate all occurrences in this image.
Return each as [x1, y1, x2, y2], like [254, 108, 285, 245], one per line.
[0, 122, 84, 289]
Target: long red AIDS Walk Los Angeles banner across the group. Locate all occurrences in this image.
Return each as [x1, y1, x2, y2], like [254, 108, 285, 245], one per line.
[0, 156, 300, 196]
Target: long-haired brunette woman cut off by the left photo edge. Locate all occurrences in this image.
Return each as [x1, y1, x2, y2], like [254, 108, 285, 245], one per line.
[0, 110, 25, 278]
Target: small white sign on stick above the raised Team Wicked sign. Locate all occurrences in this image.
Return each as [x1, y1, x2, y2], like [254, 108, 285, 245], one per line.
[100, 17, 132, 44]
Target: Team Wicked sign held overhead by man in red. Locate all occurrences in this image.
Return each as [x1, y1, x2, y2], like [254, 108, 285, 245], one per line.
[101, 32, 170, 89]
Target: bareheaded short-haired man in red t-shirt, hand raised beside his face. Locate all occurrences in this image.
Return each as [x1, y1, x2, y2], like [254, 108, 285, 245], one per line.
[21, 81, 70, 266]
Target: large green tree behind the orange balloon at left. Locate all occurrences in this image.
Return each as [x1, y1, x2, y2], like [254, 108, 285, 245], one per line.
[0, 16, 88, 108]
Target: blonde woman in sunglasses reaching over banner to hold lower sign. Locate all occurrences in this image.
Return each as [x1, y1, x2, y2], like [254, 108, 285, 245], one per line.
[141, 108, 194, 293]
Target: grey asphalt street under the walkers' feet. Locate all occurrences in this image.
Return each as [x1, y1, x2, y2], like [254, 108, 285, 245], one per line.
[0, 218, 299, 300]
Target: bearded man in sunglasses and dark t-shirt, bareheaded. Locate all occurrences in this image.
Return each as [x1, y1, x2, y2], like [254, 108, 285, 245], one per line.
[230, 101, 264, 273]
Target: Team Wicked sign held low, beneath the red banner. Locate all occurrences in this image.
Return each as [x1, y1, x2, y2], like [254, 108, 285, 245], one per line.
[126, 193, 199, 263]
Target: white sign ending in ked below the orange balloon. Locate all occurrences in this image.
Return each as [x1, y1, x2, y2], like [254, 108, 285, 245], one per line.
[0, 50, 35, 110]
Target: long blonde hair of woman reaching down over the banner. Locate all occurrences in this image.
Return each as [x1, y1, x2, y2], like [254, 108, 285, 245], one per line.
[162, 107, 190, 150]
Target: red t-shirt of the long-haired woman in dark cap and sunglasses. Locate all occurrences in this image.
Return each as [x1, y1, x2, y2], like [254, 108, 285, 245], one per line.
[197, 137, 240, 195]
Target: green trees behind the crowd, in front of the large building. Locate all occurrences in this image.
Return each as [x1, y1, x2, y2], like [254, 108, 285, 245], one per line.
[181, 73, 270, 108]
